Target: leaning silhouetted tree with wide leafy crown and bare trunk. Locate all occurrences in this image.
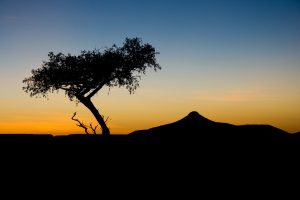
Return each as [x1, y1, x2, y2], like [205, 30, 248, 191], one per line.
[23, 38, 161, 136]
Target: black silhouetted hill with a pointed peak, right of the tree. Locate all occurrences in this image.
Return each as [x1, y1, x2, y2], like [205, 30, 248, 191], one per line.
[131, 112, 290, 145]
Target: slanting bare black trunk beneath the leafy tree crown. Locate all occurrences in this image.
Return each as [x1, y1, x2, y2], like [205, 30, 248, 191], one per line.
[78, 97, 110, 136]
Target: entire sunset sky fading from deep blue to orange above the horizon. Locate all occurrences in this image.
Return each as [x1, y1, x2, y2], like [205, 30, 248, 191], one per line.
[0, 0, 300, 135]
